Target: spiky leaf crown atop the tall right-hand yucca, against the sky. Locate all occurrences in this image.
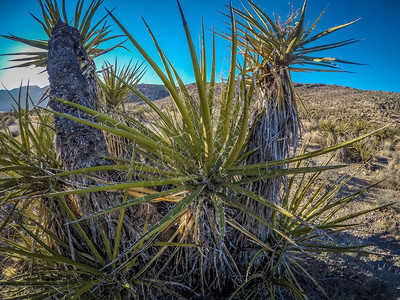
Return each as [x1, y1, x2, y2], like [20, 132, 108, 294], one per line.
[234, 1, 358, 72]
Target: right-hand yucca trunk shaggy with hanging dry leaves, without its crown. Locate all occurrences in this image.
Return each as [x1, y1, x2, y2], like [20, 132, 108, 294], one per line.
[236, 68, 299, 266]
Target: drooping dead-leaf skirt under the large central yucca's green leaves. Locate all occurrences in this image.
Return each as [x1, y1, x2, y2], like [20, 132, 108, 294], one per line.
[171, 193, 241, 299]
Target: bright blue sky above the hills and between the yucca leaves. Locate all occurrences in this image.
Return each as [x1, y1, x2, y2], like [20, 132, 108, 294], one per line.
[0, 0, 400, 92]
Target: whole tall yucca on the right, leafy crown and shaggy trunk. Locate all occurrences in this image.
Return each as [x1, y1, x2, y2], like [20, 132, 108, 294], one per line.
[228, 1, 357, 251]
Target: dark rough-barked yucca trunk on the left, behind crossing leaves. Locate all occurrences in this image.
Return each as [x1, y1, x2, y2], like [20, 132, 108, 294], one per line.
[47, 21, 156, 253]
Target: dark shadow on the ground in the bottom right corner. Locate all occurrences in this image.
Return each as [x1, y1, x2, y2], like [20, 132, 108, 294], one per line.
[303, 233, 400, 300]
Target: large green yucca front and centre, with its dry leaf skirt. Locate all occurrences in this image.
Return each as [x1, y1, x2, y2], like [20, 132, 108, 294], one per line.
[48, 1, 386, 295]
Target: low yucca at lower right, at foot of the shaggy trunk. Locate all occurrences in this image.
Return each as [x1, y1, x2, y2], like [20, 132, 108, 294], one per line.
[231, 147, 388, 299]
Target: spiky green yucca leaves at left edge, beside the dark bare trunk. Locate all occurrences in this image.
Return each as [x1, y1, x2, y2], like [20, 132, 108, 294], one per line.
[0, 85, 61, 196]
